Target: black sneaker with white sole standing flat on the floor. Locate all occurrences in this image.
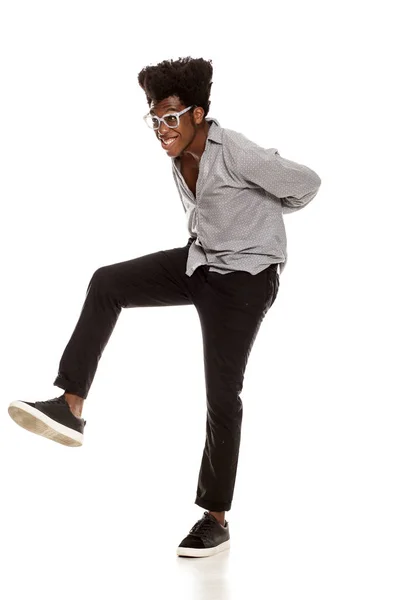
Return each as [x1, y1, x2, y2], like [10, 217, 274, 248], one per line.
[177, 512, 230, 557]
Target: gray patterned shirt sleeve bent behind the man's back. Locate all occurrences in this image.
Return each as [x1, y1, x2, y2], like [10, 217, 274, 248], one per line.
[235, 143, 321, 213]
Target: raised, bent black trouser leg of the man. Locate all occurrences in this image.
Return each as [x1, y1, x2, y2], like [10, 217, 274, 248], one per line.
[54, 239, 200, 398]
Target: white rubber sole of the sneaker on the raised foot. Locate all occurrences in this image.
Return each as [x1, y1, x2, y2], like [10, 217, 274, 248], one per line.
[8, 400, 83, 447]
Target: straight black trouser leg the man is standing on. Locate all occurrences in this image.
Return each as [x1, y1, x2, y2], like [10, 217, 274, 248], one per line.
[195, 266, 279, 511]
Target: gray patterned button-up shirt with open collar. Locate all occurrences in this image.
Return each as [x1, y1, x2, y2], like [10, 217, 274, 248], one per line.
[171, 118, 321, 276]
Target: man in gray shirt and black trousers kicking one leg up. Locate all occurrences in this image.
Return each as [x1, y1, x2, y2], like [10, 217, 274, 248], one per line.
[9, 57, 321, 557]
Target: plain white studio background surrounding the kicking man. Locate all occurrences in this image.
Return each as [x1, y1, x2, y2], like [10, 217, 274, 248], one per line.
[0, 0, 400, 600]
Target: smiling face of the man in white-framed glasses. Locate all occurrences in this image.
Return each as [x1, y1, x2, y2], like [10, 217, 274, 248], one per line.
[150, 96, 203, 158]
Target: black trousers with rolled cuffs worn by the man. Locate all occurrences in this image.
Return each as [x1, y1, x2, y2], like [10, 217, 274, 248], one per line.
[54, 238, 279, 511]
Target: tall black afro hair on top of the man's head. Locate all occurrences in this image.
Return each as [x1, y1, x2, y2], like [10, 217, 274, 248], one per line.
[138, 56, 213, 116]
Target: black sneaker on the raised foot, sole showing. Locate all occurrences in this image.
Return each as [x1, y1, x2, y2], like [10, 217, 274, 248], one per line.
[8, 394, 86, 446]
